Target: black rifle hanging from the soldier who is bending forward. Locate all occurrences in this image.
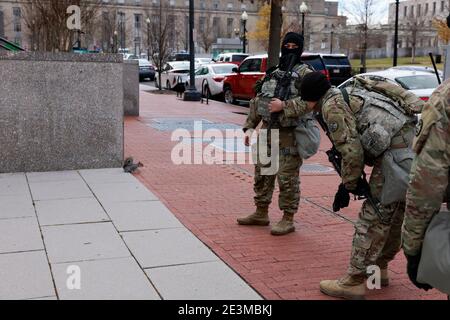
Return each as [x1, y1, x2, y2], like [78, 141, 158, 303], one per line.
[315, 113, 390, 224]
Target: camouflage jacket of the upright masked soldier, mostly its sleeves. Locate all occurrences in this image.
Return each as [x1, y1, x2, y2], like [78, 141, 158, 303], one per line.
[243, 66, 312, 132]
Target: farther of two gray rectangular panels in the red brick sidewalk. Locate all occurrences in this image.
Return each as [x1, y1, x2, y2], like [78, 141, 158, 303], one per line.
[149, 118, 241, 131]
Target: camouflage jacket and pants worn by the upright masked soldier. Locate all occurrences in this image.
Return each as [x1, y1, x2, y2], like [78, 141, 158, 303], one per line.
[243, 65, 312, 216]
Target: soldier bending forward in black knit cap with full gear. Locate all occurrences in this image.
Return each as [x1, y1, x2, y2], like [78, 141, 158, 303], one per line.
[299, 72, 423, 299]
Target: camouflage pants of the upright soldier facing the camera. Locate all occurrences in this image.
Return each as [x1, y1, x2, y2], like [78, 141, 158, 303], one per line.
[253, 126, 303, 214]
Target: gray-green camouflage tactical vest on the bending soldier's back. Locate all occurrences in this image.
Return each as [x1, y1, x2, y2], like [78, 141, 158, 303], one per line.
[330, 87, 416, 158]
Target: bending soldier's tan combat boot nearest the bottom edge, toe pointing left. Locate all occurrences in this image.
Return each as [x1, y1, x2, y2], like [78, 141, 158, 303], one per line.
[320, 275, 366, 300]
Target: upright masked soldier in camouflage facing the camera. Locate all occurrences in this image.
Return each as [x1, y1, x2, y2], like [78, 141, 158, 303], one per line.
[237, 32, 312, 235]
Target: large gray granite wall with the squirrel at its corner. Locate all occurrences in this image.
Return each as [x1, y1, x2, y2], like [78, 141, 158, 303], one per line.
[0, 53, 124, 173]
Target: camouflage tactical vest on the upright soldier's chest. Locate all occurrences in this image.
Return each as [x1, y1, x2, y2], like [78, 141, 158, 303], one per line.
[255, 64, 308, 127]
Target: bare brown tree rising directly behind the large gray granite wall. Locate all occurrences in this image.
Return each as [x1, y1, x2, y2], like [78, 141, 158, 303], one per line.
[23, 0, 102, 51]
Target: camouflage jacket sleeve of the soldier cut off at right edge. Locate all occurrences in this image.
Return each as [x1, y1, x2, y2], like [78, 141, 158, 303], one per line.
[402, 79, 450, 256]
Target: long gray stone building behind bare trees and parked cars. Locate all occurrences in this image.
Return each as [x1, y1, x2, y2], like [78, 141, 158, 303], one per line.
[0, 0, 346, 55]
